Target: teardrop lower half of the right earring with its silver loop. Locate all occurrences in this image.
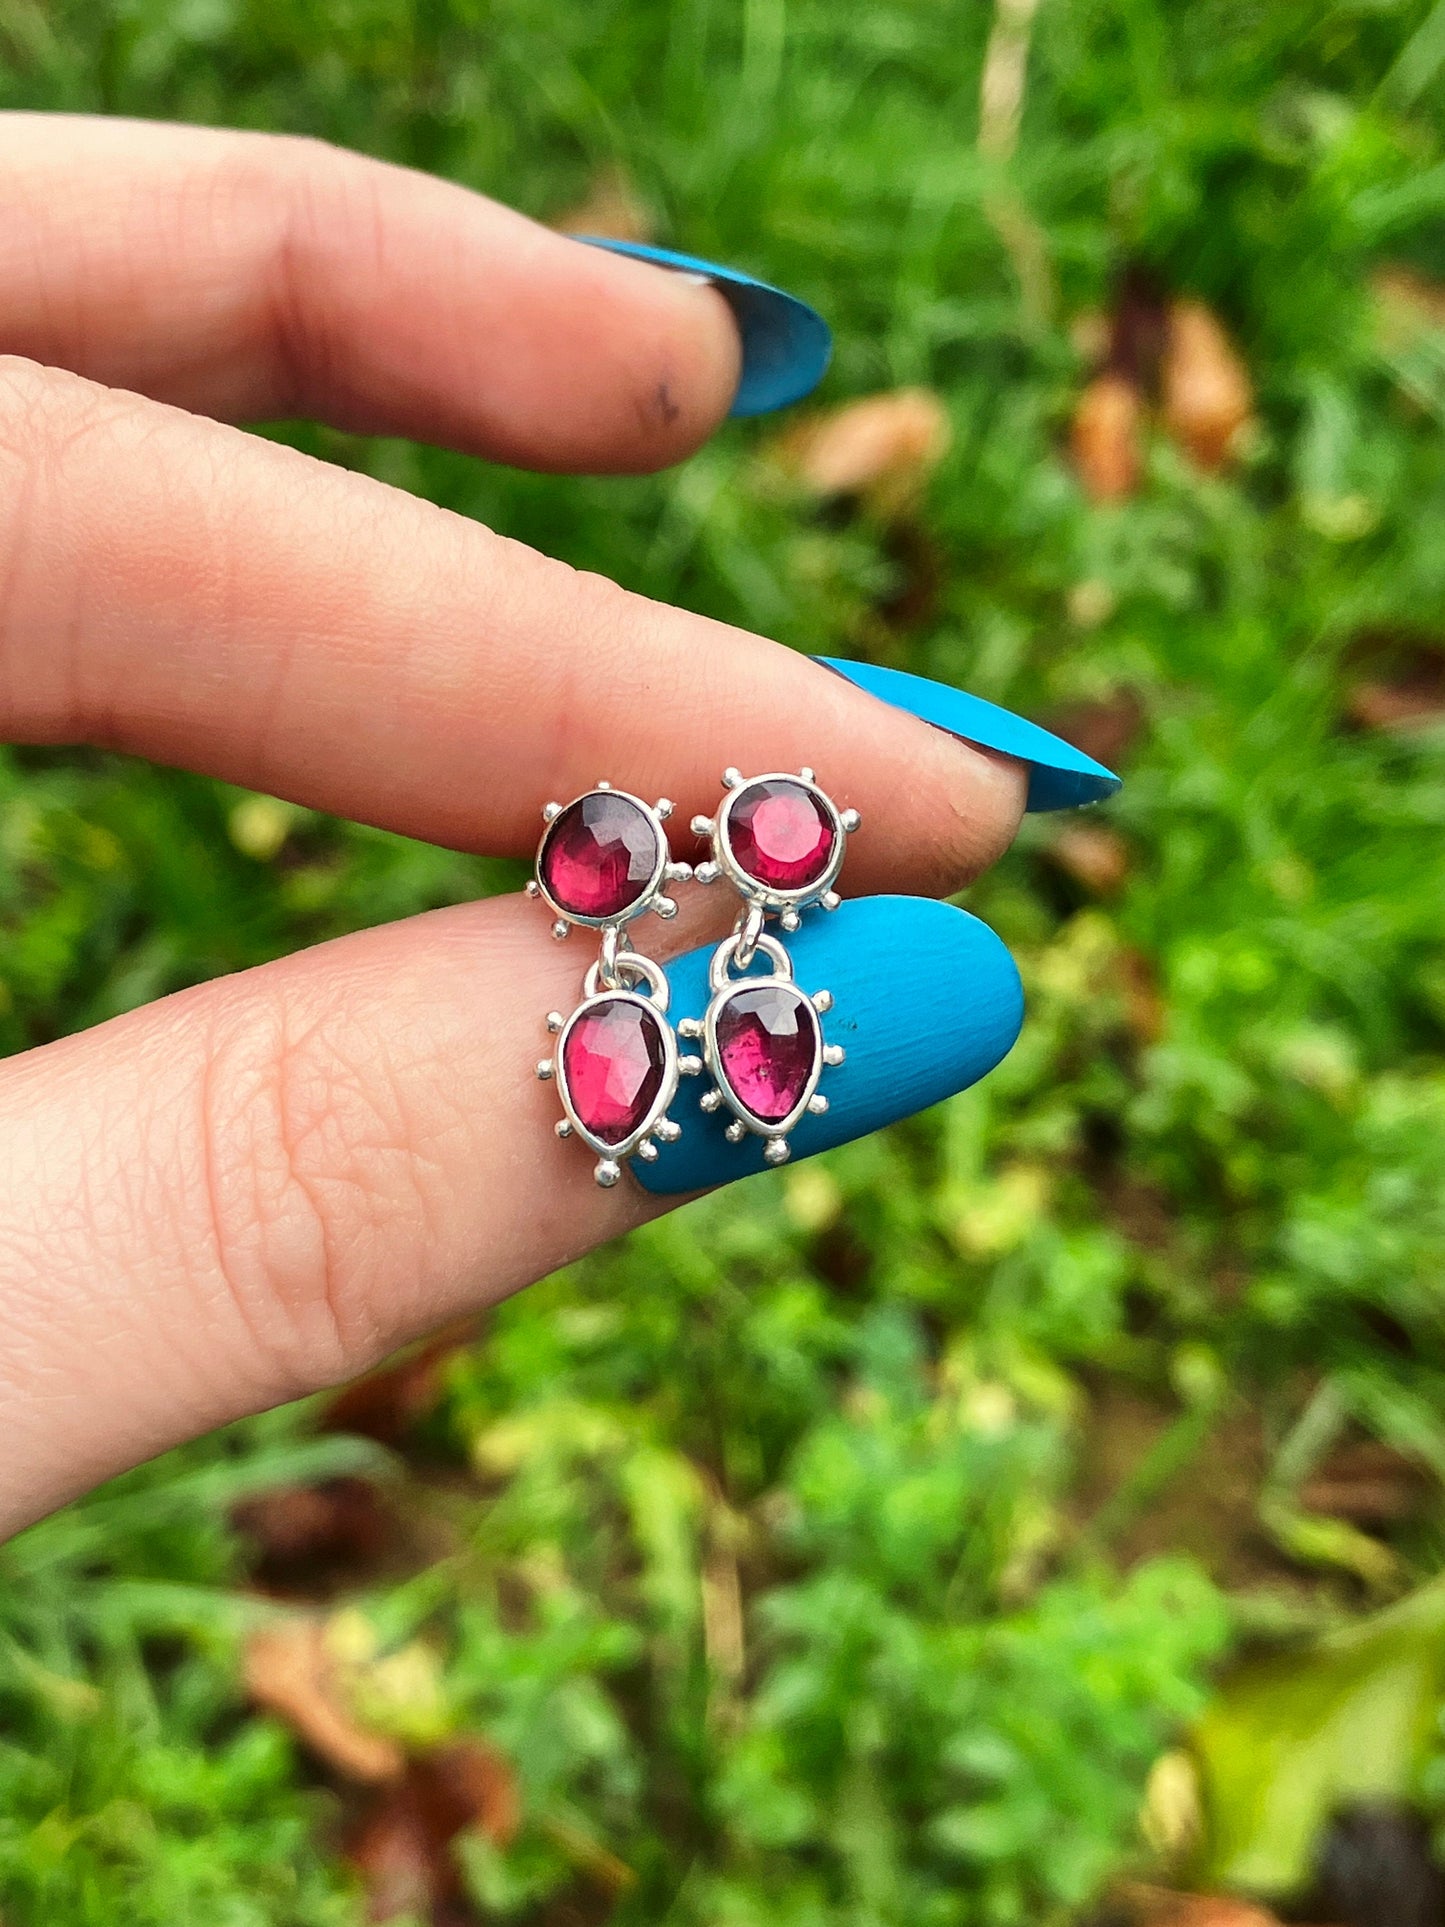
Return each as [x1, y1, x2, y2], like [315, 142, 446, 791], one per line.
[678, 931, 844, 1164]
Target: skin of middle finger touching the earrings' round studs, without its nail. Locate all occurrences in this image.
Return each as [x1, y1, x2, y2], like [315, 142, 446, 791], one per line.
[0, 362, 1025, 890]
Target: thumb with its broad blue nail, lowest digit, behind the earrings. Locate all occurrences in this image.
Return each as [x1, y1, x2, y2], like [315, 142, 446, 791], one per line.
[0, 882, 1019, 1530]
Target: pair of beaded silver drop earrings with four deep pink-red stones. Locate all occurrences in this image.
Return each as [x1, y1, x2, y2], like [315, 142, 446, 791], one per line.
[528, 769, 859, 1185]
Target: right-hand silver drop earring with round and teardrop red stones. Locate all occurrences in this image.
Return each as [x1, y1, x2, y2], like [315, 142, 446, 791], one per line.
[678, 769, 859, 1164]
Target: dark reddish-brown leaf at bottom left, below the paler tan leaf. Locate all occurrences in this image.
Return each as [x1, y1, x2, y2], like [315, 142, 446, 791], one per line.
[347, 1738, 520, 1921]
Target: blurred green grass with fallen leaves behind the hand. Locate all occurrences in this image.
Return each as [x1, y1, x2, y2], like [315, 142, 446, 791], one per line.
[0, 0, 1445, 1927]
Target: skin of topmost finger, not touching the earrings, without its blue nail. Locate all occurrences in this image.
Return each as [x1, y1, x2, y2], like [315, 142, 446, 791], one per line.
[0, 114, 740, 472]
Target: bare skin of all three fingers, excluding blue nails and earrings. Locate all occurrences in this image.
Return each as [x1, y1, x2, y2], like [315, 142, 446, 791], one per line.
[0, 116, 1025, 1530]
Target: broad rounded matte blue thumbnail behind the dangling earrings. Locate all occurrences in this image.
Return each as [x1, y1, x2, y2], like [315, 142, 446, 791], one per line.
[632, 896, 1023, 1195]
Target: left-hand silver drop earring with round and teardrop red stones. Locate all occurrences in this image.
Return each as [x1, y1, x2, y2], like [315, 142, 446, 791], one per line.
[528, 782, 703, 1187]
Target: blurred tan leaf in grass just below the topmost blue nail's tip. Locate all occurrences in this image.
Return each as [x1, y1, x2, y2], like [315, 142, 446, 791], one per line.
[776, 387, 952, 505]
